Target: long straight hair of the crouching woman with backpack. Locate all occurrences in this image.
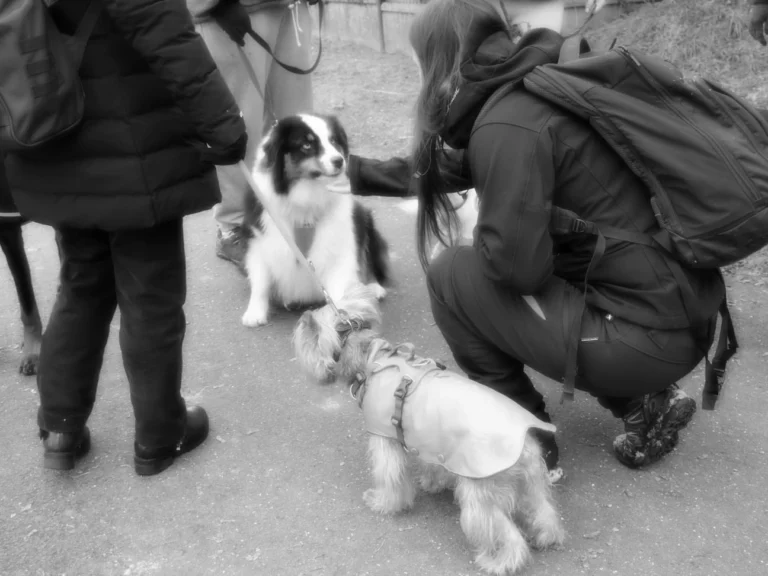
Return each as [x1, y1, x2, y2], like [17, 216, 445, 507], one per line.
[410, 0, 508, 270]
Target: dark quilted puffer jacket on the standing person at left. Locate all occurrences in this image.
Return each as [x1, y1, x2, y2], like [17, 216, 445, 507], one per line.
[5, 0, 245, 230]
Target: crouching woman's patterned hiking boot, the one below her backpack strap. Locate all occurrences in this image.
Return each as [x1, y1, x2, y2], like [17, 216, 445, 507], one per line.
[613, 384, 696, 468]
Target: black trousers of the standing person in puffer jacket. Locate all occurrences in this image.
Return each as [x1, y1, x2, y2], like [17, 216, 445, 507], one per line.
[37, 220, 187, 448]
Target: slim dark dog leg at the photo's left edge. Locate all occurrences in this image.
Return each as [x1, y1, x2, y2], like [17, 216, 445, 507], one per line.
[0, 222, 43, 376]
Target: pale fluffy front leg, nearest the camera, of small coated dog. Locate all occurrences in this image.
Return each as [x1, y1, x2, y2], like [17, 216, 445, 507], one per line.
[363, 434, 416, 514]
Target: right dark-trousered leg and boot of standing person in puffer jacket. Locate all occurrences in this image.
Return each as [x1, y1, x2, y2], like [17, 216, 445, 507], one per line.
[110, 219, 208, 475]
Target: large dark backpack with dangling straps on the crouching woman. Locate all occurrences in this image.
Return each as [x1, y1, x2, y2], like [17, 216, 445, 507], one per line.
[476, 37, 744, 410]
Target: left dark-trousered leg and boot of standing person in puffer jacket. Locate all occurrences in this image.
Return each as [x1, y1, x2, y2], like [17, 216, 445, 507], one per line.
[37, 228, 117, 470]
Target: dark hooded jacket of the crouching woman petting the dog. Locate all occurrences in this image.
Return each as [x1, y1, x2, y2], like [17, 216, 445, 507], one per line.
[351, 29, 725, 329]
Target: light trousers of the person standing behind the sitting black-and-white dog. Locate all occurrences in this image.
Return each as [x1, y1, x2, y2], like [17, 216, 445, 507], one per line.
[197, 2, 312, 233]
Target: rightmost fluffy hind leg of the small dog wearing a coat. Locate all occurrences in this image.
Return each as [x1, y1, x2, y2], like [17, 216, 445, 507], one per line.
[515, 435, 565, 549]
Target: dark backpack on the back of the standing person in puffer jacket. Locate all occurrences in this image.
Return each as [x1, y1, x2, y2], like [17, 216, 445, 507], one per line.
[0, 0, 101, 152]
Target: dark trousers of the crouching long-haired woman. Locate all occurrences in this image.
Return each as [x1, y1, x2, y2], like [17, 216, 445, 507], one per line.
[428, 247, 706, 417]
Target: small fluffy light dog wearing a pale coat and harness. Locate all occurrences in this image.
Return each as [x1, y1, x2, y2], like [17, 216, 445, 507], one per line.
[294, 288, 565, 574]
